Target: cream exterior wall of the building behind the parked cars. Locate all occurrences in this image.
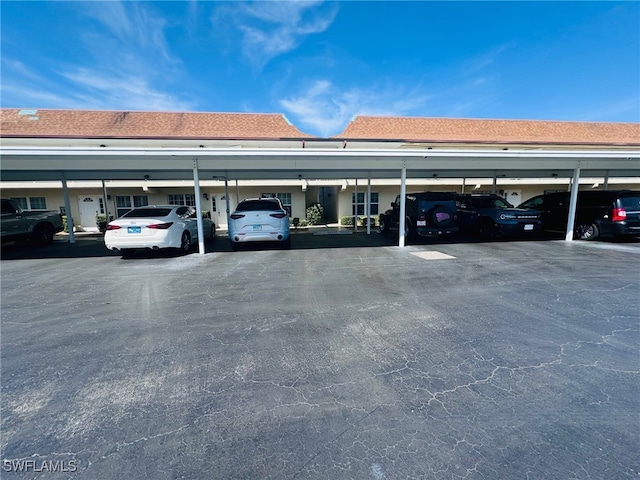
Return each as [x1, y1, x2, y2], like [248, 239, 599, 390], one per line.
[0, 177, 640, 227]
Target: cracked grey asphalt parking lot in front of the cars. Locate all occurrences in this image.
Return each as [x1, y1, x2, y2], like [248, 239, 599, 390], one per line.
[0, 232, 640, 480]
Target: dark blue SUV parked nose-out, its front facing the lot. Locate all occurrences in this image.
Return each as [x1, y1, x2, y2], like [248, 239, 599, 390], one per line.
[456, 194, 542, 239]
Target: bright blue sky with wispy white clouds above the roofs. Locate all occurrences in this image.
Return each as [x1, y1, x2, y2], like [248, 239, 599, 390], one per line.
[0, 0, 640, 137]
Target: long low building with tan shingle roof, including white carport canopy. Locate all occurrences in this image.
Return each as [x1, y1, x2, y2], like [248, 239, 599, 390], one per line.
[0, 109, 640, 236]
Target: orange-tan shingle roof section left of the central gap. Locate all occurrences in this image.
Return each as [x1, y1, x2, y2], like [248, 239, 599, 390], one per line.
[0, 109, 310, 139]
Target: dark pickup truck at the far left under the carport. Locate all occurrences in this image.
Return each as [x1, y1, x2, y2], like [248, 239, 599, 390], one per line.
[0, 198, 64, 245]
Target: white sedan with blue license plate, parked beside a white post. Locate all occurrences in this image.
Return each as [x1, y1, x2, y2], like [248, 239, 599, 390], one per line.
[104, 205, 216, 255]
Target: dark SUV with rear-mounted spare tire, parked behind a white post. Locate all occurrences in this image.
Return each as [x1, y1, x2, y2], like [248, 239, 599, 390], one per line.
[378, 192, 458, 240]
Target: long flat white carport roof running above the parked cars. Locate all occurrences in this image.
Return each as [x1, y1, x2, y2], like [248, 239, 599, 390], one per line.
[0, 144, 640, 181]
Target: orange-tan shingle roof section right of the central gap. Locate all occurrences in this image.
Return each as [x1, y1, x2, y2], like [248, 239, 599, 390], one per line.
[336, 116, 640, 145]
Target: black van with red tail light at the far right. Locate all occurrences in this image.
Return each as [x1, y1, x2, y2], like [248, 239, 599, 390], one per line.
[520, 190, 640, 240]
